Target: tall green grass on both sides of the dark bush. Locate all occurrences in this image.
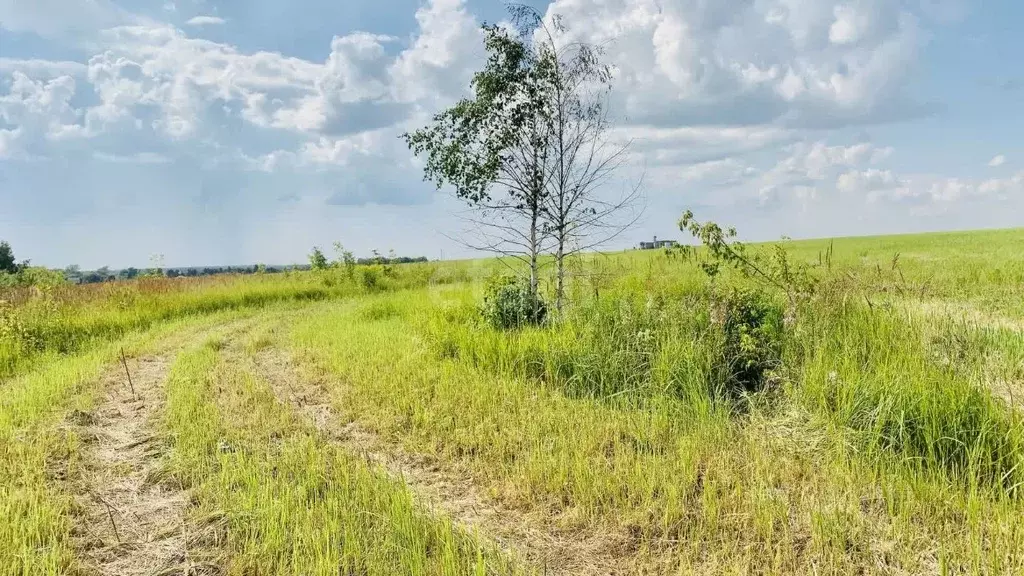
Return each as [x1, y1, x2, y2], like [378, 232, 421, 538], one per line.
[420, 252, 1024, 494]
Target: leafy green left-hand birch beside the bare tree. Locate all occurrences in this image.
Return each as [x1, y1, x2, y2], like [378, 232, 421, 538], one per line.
[404, 17, 551, 302]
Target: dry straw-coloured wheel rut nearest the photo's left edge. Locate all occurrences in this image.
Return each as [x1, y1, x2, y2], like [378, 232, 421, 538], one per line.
[69, 357, 208, 576]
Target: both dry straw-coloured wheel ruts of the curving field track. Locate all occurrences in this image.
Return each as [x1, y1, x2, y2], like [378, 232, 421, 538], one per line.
[69, 315, 636, 576]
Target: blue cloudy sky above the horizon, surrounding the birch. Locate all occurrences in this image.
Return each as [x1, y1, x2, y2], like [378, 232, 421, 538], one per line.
[0, 0, 1024, 269]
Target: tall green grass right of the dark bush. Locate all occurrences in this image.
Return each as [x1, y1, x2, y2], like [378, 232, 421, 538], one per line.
[790, 305, 1024, 495]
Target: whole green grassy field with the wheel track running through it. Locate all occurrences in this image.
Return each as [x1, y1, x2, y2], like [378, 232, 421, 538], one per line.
[0, 230, 1024, 575]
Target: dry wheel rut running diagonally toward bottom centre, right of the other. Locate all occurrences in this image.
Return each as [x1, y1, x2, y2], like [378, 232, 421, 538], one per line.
[247, 342, 635, 576]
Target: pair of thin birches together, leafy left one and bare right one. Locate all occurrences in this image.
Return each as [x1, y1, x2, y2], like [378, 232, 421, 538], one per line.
[403, 3, 626, 314]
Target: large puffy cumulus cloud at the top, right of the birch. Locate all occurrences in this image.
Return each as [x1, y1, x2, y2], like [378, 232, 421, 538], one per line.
[548, 0, 924, 127]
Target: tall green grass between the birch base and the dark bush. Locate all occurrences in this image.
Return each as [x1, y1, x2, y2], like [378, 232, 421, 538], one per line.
[422, 282, 723, 402]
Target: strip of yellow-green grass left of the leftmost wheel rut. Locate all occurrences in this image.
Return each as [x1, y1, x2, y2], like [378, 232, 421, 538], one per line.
[0, 314, 268, 575]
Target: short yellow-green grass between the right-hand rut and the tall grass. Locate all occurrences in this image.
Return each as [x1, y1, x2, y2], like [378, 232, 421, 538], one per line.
[293, 289, 1024, 574]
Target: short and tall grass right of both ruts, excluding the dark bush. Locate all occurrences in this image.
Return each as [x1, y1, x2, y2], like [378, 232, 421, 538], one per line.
[293, 278, 1024, 574]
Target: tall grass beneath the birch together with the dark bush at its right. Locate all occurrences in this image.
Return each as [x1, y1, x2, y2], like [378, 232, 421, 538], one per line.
[428, 276, 782, 401]
